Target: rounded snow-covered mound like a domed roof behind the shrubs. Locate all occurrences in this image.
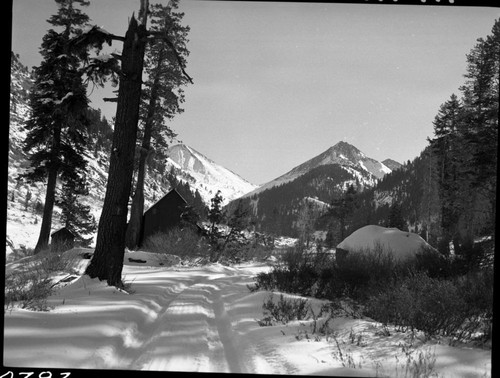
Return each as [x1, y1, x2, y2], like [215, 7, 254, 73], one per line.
[336, 225, 433, 261]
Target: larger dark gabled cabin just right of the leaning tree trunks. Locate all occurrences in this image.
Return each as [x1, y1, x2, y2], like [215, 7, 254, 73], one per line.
[139, 189, 187, 245]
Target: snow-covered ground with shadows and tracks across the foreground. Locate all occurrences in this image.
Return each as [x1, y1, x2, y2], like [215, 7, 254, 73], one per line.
[3, 249, 491, 377]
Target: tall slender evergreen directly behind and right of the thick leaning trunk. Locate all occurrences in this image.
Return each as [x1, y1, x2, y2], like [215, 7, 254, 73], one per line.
[126, 0, 189, 249]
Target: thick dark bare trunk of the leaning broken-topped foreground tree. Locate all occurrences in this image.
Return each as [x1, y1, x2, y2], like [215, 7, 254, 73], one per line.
[85, 16, 147, 287]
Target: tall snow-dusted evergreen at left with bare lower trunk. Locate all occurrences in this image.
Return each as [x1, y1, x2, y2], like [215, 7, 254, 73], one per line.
[22, 0, 89, 253]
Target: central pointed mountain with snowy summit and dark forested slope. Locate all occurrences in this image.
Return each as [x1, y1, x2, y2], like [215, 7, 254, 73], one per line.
[227, 141, 398, 237]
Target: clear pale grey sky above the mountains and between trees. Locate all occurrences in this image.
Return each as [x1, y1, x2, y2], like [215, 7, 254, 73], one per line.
[12, 0, 500, 184]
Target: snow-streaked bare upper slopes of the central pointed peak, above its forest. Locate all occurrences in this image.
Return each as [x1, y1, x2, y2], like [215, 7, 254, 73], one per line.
[246, 142, 391, 196]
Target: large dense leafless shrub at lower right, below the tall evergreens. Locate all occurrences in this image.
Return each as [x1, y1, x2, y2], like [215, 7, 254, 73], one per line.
[365, 272, 493, 341]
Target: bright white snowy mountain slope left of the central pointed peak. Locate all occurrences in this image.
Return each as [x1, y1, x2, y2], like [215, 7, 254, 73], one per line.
[167, 144, 257, 204]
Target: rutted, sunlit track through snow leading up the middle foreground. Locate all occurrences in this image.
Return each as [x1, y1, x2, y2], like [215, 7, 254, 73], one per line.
[119, 266, 296, 374]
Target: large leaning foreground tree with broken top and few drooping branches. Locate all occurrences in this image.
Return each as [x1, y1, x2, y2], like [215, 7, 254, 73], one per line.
[73, 0, 190, 287]
